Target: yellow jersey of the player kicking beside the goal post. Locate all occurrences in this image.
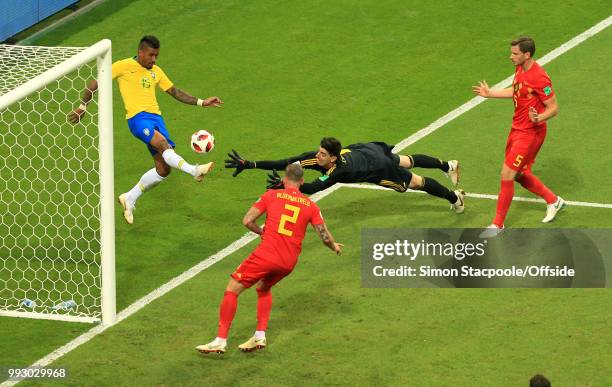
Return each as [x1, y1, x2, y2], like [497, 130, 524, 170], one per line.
[113, 58, 173, 119]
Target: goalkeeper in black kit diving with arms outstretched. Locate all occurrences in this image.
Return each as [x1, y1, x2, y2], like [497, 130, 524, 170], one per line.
[225, 137, 465, 213]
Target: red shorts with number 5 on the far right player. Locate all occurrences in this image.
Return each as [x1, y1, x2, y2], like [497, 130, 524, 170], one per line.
[504, 129, 546, 172]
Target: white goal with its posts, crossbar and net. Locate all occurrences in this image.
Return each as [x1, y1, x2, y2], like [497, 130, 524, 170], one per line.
[0, 39, 116, 325]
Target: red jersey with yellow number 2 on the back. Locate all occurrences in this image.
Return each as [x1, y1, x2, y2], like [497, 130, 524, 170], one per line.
[253, 188, 323, 267]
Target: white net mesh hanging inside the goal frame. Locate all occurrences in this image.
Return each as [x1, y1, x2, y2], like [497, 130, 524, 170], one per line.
[0, 45, 101, 317]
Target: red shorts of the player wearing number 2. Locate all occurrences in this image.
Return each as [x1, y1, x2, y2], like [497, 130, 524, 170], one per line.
[230, 254, 295, 288]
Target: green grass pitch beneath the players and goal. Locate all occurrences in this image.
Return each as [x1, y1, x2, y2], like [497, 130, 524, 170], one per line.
[0, 0, 612, 386]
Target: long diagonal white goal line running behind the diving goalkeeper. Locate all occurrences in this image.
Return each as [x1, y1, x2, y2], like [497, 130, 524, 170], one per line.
[0, 12, 612, 387]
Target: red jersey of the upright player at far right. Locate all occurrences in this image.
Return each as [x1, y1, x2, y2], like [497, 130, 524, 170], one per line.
[512, 62, 555, 131]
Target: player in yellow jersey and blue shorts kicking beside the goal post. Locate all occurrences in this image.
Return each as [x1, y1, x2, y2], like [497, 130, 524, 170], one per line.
[69, 35, 223, 224]
